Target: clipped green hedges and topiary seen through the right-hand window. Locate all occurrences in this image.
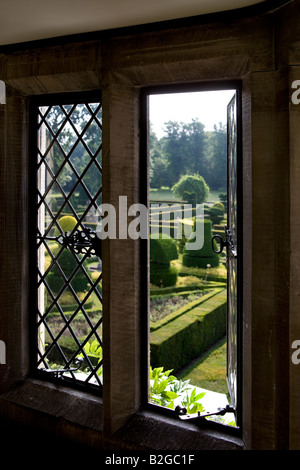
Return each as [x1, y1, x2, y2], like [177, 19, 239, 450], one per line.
[150, 195, 227, 373]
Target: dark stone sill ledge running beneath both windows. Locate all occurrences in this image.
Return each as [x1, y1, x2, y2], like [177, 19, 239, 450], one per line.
[0, 379, 243, 452]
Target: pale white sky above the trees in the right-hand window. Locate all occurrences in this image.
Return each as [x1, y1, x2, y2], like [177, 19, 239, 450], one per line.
[149, 90, 234, 138]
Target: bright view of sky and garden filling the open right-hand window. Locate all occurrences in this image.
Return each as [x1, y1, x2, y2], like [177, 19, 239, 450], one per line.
[148, 90, 234, 425]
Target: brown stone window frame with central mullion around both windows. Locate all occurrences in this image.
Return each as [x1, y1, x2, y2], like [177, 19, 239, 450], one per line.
[0, 1, 290, 450]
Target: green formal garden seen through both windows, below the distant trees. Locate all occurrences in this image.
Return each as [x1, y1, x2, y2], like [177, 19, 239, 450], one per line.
[39, 182, 232, 420]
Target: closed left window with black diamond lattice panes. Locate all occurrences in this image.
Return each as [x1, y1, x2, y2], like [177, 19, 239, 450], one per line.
[31, 93, 102, 393]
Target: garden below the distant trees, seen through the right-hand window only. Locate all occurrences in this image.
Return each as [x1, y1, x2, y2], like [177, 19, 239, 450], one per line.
[145, 177, 234, 425]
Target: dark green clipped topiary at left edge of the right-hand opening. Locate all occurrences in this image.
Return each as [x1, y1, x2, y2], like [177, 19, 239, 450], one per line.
[150, 234, 178, 287]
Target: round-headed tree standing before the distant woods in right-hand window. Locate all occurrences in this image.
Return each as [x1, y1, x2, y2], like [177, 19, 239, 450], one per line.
[172, 175, 209, 205]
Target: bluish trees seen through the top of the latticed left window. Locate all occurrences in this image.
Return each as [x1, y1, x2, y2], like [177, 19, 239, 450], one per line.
[45, 103, 102, 209]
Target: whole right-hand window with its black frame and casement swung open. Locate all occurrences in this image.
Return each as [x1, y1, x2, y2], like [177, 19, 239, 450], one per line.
[141, 83, 241, 429]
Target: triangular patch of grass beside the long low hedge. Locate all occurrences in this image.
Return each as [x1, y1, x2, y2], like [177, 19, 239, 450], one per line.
[179, 338, 228, 395]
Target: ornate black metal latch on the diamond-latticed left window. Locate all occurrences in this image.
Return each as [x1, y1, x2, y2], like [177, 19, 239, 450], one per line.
[37, 227, 102, 259]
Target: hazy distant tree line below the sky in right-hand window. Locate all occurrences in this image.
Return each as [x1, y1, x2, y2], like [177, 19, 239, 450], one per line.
[150, 119, 227, 190]
